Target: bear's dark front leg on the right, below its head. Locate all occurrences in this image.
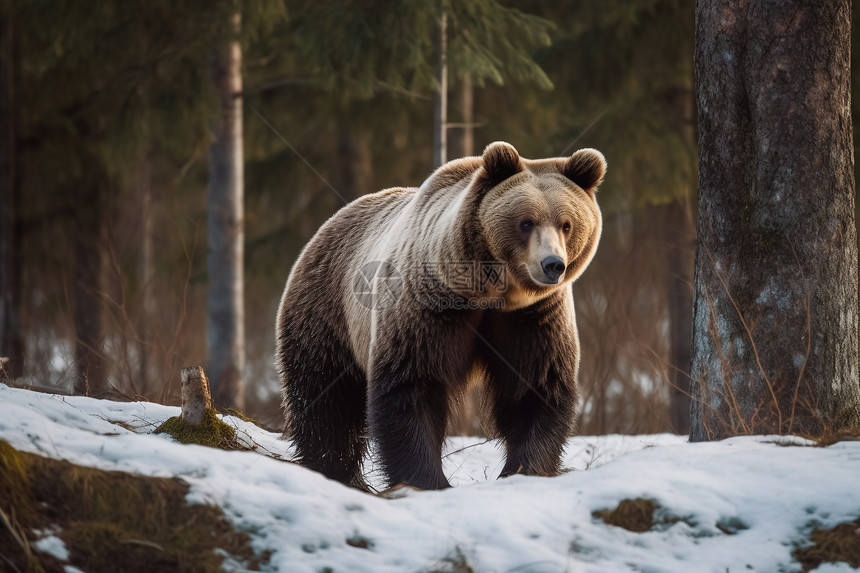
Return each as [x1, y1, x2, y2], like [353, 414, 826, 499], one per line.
[481, 289, 579, 477]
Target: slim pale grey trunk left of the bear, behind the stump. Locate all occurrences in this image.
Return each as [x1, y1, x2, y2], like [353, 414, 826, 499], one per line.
[206, 14, 245, 408]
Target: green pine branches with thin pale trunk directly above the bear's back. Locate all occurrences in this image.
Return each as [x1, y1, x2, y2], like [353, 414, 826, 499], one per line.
[282, 0, 552, 170]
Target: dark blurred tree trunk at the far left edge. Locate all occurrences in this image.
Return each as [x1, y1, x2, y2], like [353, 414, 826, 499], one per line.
[0, 14, 24, 380]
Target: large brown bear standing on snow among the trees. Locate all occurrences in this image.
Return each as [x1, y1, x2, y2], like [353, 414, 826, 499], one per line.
[276, 142, 606, 489]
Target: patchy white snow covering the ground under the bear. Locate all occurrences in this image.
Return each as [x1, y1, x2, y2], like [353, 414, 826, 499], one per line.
[0, 385, 860, 573]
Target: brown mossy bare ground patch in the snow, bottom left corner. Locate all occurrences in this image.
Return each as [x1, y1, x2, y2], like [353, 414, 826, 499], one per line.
[0, 441, 268, 573]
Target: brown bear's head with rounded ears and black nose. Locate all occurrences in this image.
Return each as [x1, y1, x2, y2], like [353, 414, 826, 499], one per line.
[472, 142, 606, 308]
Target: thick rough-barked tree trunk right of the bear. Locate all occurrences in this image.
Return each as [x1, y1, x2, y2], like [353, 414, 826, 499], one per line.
[690, 0, 860, 441]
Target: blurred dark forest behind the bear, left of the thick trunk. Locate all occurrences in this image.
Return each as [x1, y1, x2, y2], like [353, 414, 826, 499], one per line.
[0, 0, 848, 434]
